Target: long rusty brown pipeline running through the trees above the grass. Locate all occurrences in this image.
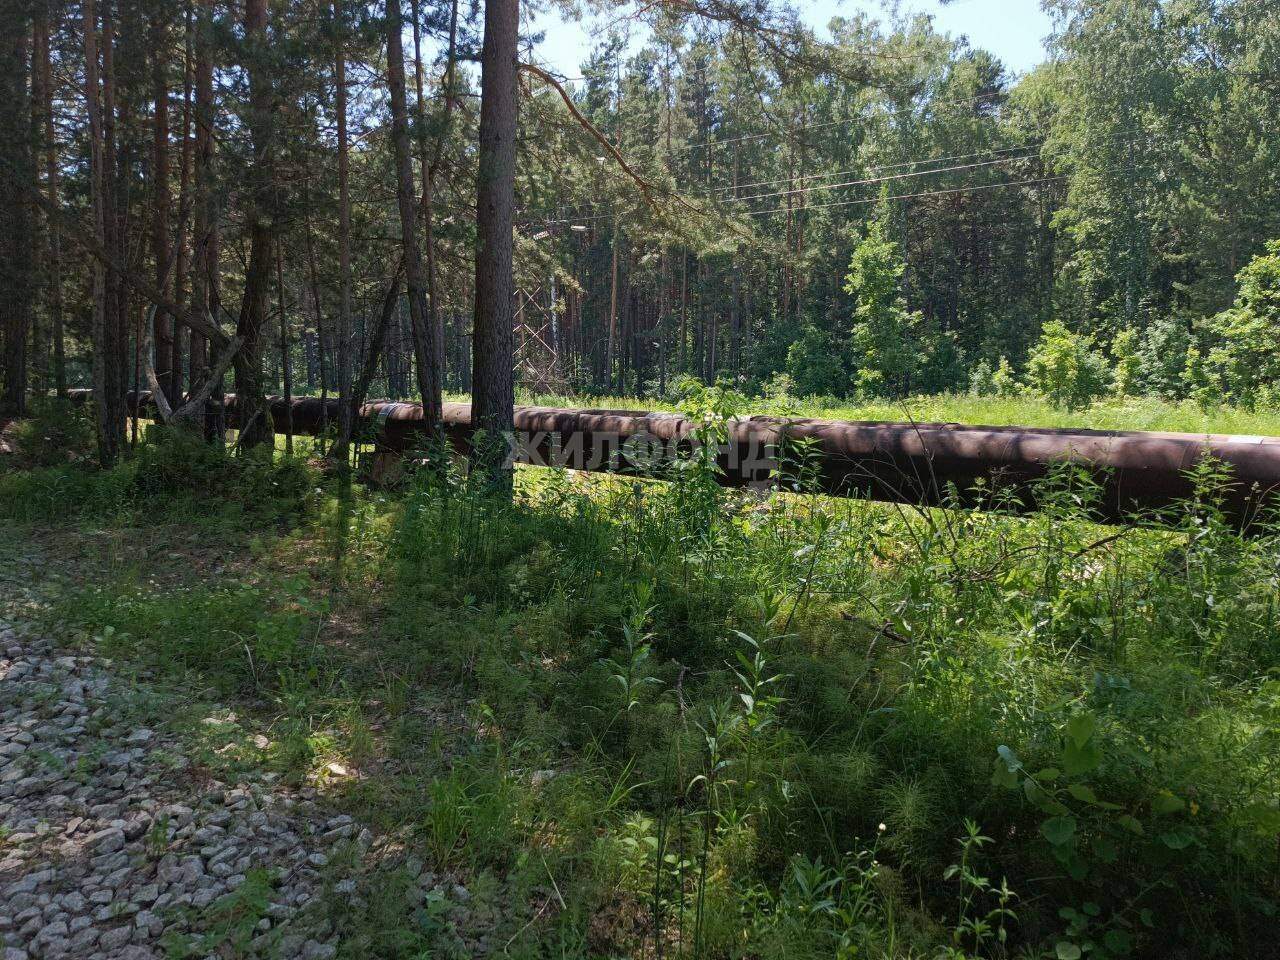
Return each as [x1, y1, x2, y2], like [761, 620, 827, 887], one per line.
[72, 390, 1280, 524]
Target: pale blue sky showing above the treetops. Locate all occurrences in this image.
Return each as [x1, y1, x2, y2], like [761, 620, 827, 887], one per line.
[524, 0, 1050, 77]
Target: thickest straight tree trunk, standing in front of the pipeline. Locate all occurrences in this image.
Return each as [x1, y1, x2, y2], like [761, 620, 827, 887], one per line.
[471, 0, 520, 490]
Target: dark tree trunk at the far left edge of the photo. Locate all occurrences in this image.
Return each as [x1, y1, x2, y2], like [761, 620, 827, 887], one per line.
[0, 4, 36, 416]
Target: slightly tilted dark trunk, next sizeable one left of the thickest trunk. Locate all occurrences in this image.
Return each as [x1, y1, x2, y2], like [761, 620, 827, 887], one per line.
[387, 0, 442, 431]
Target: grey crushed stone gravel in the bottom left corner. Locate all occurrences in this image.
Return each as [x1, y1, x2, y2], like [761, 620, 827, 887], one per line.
[0, 621, 372, 960]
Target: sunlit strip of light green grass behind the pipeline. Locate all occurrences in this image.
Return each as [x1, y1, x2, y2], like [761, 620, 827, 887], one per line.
[494, 393, 1280, 436]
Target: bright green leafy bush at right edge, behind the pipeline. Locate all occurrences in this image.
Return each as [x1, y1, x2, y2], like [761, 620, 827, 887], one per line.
[1206, 241, 1280, 406]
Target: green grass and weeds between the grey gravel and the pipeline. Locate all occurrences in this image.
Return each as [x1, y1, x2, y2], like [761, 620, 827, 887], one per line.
[14, 417, 1280, 960]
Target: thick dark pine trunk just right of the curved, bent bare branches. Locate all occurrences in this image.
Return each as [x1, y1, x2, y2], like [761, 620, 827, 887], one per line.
[234, 0, 276, 449]
